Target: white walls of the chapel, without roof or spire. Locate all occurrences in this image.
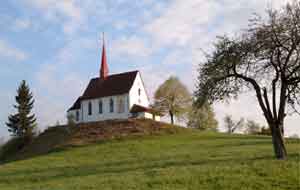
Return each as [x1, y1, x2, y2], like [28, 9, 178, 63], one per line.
[67, 72, 152, 123]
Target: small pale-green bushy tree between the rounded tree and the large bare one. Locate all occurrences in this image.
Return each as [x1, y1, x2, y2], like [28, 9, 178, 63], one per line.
[187, 103, 218, 131]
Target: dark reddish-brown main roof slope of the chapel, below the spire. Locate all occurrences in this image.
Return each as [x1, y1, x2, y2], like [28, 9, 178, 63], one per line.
[80, 71, 138, 100]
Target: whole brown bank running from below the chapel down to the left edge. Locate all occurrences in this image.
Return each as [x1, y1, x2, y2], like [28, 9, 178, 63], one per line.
[1, 119, 186, 161]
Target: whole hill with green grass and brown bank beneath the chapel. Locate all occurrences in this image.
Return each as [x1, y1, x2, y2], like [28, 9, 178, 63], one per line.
[0, 121, 300, 190]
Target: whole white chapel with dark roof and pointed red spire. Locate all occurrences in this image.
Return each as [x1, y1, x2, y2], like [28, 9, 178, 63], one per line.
[67, 40, 160, 123]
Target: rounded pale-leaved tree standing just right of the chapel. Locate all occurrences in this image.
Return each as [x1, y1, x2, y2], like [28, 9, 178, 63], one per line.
[154, 77, 191, 124]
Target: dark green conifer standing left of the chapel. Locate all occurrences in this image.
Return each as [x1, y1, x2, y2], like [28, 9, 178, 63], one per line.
[6, 80, 36, 138]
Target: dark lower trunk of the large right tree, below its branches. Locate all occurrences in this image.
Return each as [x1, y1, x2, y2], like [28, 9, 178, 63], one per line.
[270, 124, 287, 160]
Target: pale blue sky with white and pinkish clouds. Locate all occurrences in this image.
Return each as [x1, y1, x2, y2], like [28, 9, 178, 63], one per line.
[0, 0, 300, 136]
